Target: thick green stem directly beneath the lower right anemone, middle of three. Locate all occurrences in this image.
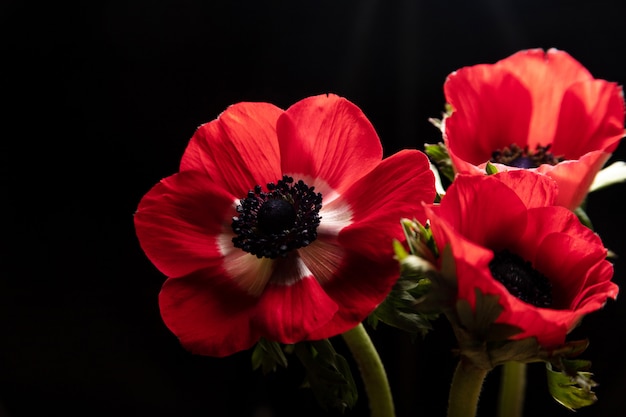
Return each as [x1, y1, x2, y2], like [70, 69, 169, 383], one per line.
[448, 358, 489, 417]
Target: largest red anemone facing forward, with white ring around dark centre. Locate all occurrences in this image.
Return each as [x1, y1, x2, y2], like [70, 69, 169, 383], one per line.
[134, 95, 435, 356]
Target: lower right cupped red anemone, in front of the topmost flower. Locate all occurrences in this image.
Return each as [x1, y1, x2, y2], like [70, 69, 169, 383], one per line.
[426, 170, 618, 348]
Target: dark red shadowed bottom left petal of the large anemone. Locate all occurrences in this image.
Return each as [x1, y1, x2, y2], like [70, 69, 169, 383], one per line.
[159, 268, 260, 357]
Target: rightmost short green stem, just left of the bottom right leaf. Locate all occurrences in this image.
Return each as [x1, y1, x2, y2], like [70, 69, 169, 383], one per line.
[498, 362, 526, 417]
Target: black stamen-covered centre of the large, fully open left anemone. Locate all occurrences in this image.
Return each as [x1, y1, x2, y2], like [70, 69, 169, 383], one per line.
[232, 176, 322, 259]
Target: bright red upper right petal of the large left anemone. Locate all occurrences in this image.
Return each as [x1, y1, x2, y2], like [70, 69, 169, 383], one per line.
[277, 94, 382, 193]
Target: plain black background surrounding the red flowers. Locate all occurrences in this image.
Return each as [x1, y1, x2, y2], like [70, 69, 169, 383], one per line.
[0, 0, 626, 417]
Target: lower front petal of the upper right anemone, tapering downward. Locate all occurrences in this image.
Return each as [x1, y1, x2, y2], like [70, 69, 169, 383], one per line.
[537, 151, 611, 210]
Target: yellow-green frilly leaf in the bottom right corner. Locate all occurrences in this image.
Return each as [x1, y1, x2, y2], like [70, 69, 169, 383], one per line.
[546, 359, 598, 411]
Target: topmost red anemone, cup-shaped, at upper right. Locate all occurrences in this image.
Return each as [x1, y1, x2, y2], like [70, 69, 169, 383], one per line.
[444, 49, 624, 210]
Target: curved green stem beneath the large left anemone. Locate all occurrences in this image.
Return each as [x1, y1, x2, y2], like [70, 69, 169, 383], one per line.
[342, 324, 396, 417]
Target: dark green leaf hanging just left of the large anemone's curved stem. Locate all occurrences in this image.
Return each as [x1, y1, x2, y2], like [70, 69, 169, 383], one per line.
[294, 339, 358, 413]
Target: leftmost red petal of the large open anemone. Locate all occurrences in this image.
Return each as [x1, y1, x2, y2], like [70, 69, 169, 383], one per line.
[134, 171, 235, 277]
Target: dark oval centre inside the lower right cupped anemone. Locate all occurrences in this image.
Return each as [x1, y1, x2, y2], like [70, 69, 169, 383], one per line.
[489, 250, 552, 308]
